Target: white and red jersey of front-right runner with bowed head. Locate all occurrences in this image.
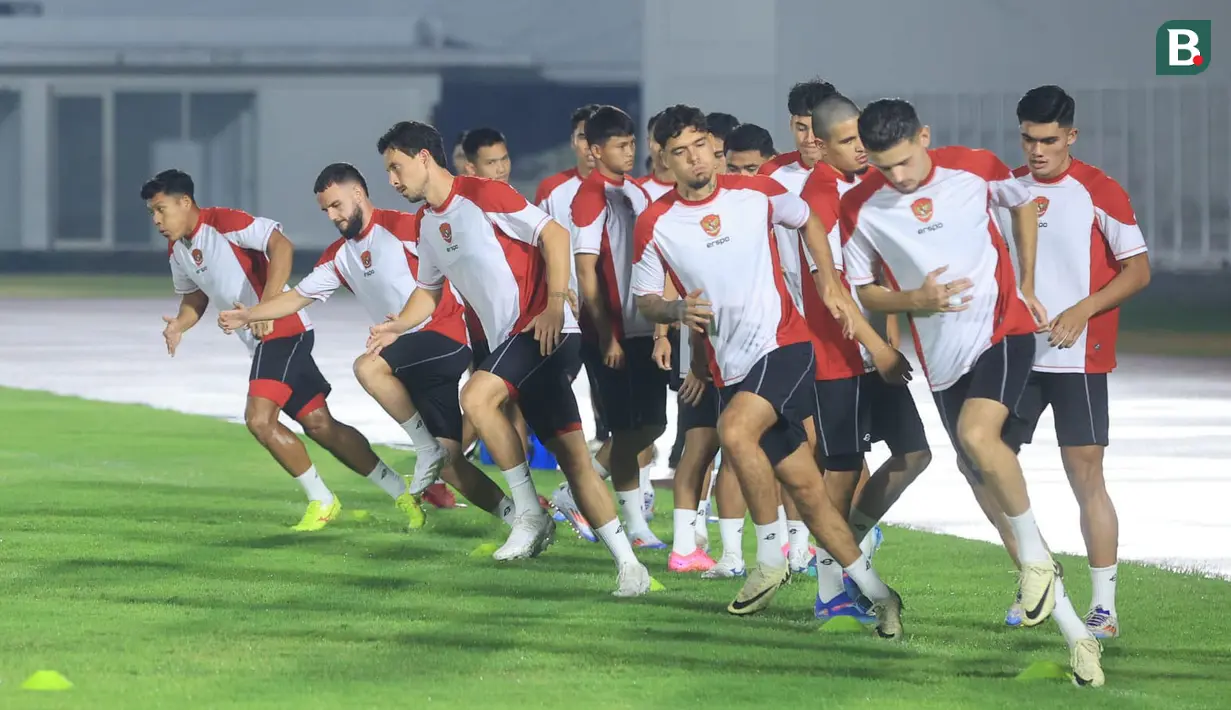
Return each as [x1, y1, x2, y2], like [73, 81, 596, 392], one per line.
[840, 146, 1035, 391]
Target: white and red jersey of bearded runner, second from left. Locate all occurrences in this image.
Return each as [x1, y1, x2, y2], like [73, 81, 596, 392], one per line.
[295, 209, 469, 345]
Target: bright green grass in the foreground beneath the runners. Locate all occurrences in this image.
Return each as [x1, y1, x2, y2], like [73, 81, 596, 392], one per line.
[0, 389, 1231, 710]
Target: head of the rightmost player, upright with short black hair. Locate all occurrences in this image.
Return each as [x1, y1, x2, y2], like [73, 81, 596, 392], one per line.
[1017, 86, 1077, 178]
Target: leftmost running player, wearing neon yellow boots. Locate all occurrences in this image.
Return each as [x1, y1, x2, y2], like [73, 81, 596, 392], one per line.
[142, 170, 400, 532]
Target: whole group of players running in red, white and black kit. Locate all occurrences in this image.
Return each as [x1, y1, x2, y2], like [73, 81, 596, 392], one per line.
[142, 76, 1150, 685]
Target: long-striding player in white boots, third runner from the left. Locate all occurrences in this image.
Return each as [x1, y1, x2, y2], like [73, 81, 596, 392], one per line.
[369, 122, 651, 597]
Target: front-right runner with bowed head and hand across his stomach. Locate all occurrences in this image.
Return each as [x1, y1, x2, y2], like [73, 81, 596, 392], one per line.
[840, 98, 1103, 685]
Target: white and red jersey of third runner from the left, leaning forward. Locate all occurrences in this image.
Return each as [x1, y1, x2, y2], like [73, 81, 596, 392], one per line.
[417, 176, 579, 349]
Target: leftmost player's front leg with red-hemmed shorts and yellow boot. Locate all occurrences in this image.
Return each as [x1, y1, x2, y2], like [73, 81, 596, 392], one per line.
[244, 331, 342, 532]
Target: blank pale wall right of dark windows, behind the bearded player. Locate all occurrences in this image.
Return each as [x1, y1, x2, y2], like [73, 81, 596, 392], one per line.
[256, 78, 439, 247]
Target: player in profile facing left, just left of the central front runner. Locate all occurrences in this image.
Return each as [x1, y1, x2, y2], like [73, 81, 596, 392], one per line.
[570, 106, 667, 549]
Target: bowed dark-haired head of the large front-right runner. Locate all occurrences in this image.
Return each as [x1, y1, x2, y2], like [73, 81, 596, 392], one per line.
[859, 98, 932, 192]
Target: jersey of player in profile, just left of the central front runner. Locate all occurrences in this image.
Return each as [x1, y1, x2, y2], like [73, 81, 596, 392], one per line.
[572, 170, 654, 340]
